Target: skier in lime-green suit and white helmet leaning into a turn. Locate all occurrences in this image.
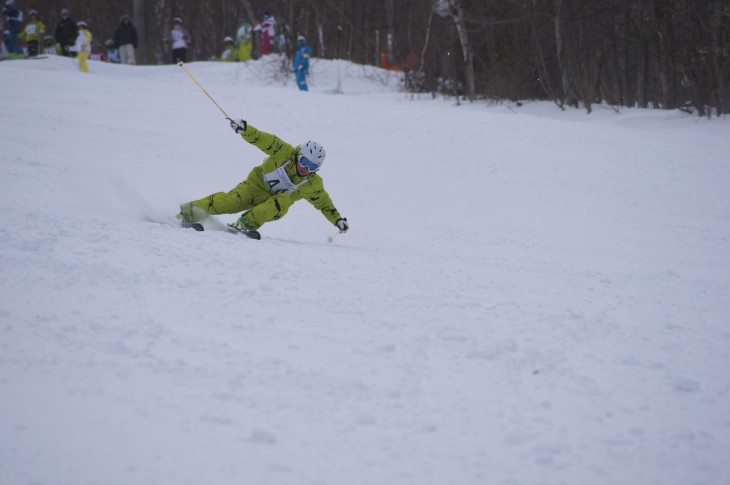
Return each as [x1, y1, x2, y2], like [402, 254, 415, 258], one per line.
[176, 120, 350, 239]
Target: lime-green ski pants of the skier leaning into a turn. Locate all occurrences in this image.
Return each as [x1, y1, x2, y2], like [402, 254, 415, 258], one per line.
[180, 174, 293, 229]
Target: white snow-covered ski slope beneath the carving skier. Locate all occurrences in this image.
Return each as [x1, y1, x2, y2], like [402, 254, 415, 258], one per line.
[0, 54, 730, 485]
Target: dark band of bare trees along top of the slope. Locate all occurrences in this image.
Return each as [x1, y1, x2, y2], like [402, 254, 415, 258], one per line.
[19, 0, 730, 116]
